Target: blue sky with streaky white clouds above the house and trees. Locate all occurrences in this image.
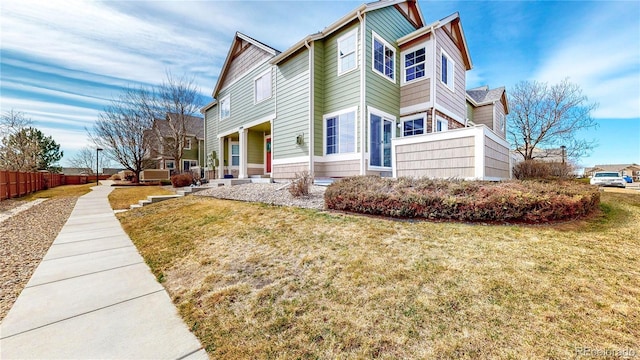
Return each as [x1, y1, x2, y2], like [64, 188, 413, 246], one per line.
[0, 0, 640, 166]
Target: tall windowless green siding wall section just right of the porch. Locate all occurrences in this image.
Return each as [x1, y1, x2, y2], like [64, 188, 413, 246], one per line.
[272, 49, 309, 159]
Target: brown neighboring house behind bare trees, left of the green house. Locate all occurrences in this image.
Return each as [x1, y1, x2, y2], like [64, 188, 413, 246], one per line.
[147, 114, 205, 172]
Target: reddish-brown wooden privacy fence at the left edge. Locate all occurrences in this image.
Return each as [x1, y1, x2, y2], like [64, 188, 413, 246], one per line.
[0, 170, 87, 200]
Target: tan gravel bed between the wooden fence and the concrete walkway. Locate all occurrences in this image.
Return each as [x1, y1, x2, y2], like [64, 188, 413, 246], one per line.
[0, 197, 78, 320]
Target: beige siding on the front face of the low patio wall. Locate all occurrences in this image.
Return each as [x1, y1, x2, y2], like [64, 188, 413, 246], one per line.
[396, 136, 475, 178]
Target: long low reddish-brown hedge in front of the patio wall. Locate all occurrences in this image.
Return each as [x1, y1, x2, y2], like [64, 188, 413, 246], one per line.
[325, 176, 600, 223]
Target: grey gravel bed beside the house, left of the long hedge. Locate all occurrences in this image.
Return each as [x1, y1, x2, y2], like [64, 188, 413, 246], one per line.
[195, 183, 326, 210]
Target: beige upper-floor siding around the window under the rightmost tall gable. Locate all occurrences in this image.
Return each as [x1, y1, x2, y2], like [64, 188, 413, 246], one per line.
[435, 28, 467, 119]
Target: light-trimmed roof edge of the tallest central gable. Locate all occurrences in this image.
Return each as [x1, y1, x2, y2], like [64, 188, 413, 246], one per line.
[271, 0, 424, 65]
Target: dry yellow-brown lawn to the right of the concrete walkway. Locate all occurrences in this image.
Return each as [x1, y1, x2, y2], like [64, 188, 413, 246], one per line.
[119, 192, 640, 359]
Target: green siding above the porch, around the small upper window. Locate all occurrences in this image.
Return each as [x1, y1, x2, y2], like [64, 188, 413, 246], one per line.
[217, 62, 276, 133]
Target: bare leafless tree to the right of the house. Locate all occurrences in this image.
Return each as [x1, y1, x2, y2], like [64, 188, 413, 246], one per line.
[508, 79, 598, 160]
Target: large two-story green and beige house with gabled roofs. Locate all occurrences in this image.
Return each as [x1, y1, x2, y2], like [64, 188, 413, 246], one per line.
[202, 0, 510, 179]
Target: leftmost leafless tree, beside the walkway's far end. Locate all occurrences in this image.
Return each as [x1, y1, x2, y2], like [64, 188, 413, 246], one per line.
[87, 88, 156, 181]
